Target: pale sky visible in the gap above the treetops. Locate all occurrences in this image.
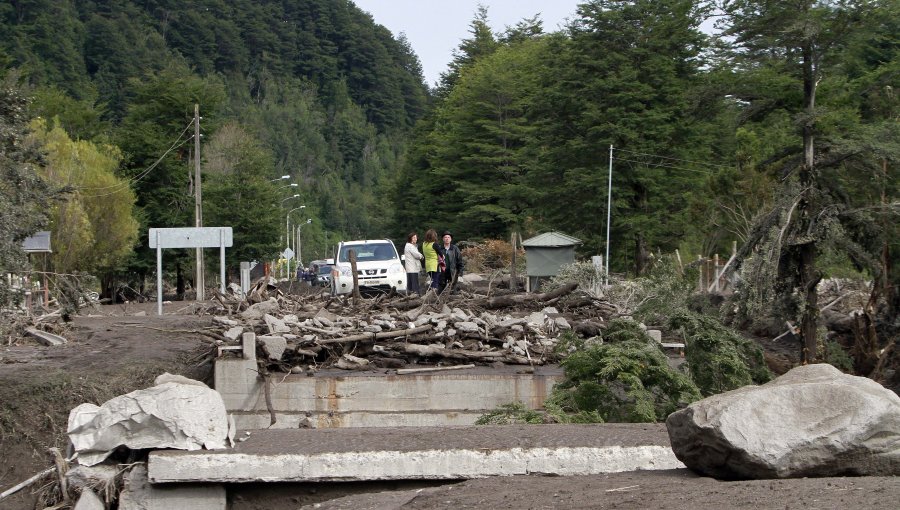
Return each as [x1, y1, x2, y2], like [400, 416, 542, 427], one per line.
[353, 0, 585, 87]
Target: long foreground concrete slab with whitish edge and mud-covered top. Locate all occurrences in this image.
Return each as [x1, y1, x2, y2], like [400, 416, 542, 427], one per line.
[148, 424, 684, 483]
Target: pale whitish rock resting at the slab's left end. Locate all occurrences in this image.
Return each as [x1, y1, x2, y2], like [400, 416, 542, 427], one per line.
[68, 381, 228, 466]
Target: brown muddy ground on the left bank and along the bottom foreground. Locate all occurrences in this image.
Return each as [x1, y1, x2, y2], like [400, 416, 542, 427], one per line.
[0, 302, 900, 510]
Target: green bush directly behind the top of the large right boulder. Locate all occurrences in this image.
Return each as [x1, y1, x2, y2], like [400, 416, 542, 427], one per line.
[669, 312, 772, 396]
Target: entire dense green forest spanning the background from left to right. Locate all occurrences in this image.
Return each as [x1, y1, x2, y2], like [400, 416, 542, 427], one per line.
[0, 0, 900, 336]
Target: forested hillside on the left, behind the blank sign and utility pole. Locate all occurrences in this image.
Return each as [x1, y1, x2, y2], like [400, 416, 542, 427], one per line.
[0, 0, 429, 294]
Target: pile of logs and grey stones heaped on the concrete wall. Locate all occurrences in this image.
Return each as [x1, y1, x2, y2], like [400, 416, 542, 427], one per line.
[214, 281, 618, 373]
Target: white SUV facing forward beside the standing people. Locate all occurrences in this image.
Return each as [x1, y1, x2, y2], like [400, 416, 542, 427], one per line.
[331, 239, 406, 295]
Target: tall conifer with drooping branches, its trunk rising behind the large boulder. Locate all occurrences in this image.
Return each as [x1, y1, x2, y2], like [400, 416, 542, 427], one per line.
[720, 0, 896, 362]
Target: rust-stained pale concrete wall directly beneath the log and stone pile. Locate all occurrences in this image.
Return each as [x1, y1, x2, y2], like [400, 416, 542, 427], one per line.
[215, 358, 563, 429]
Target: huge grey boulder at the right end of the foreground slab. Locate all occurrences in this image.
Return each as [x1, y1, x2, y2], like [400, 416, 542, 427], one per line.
[666, 364, 900, 479]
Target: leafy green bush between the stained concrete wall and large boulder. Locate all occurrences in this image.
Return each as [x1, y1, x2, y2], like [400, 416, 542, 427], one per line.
[546, 320, 700, 423]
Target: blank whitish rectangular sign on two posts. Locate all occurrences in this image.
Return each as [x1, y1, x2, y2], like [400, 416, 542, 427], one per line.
[148, 227, 234, 315]
